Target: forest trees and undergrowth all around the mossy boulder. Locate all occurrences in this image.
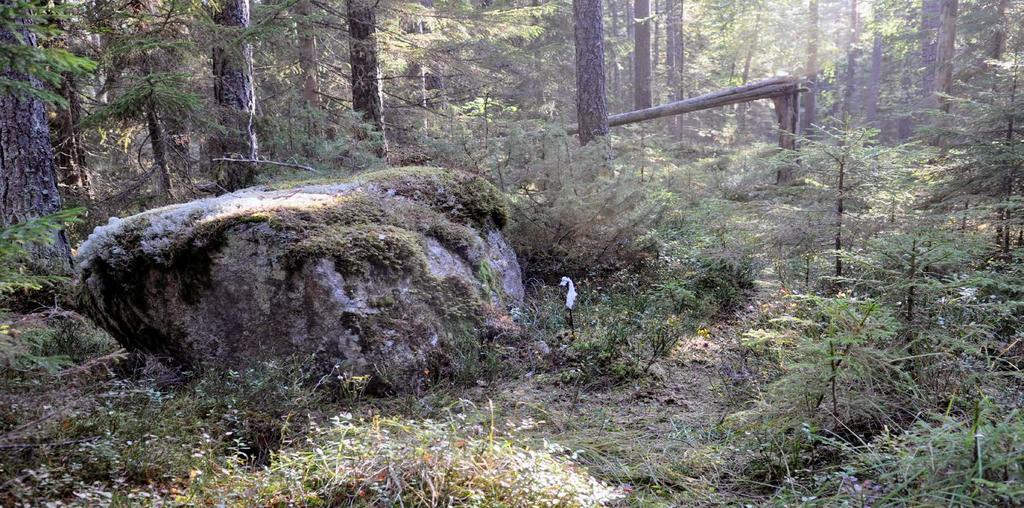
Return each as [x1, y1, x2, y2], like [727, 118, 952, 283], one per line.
[0, 0, 1024, 506]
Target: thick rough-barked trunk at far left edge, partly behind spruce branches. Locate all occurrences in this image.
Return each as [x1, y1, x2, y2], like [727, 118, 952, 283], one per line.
[0, 6, 71, 272]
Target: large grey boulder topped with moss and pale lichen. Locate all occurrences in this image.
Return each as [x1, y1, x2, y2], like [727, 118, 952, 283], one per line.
[77, 168, 523, 389]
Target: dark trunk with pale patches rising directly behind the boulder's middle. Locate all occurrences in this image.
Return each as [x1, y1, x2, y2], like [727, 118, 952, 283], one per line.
[211, 0, 259, 191]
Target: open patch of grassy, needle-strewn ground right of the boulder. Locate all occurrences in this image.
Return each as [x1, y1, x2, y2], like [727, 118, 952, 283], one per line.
[397, 270, 779, 506]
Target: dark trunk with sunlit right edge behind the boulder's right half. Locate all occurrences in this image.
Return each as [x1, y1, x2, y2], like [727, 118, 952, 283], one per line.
[348, 0, 387, 159]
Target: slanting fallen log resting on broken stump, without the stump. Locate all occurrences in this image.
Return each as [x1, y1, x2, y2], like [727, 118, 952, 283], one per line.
[568, 77, 800, 134]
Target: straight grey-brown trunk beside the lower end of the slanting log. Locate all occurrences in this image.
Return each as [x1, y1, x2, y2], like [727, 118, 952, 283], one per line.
[572, 0, 606, 144]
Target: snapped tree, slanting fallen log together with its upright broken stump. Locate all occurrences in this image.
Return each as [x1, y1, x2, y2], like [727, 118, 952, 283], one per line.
[567, 77, 802, 150]
